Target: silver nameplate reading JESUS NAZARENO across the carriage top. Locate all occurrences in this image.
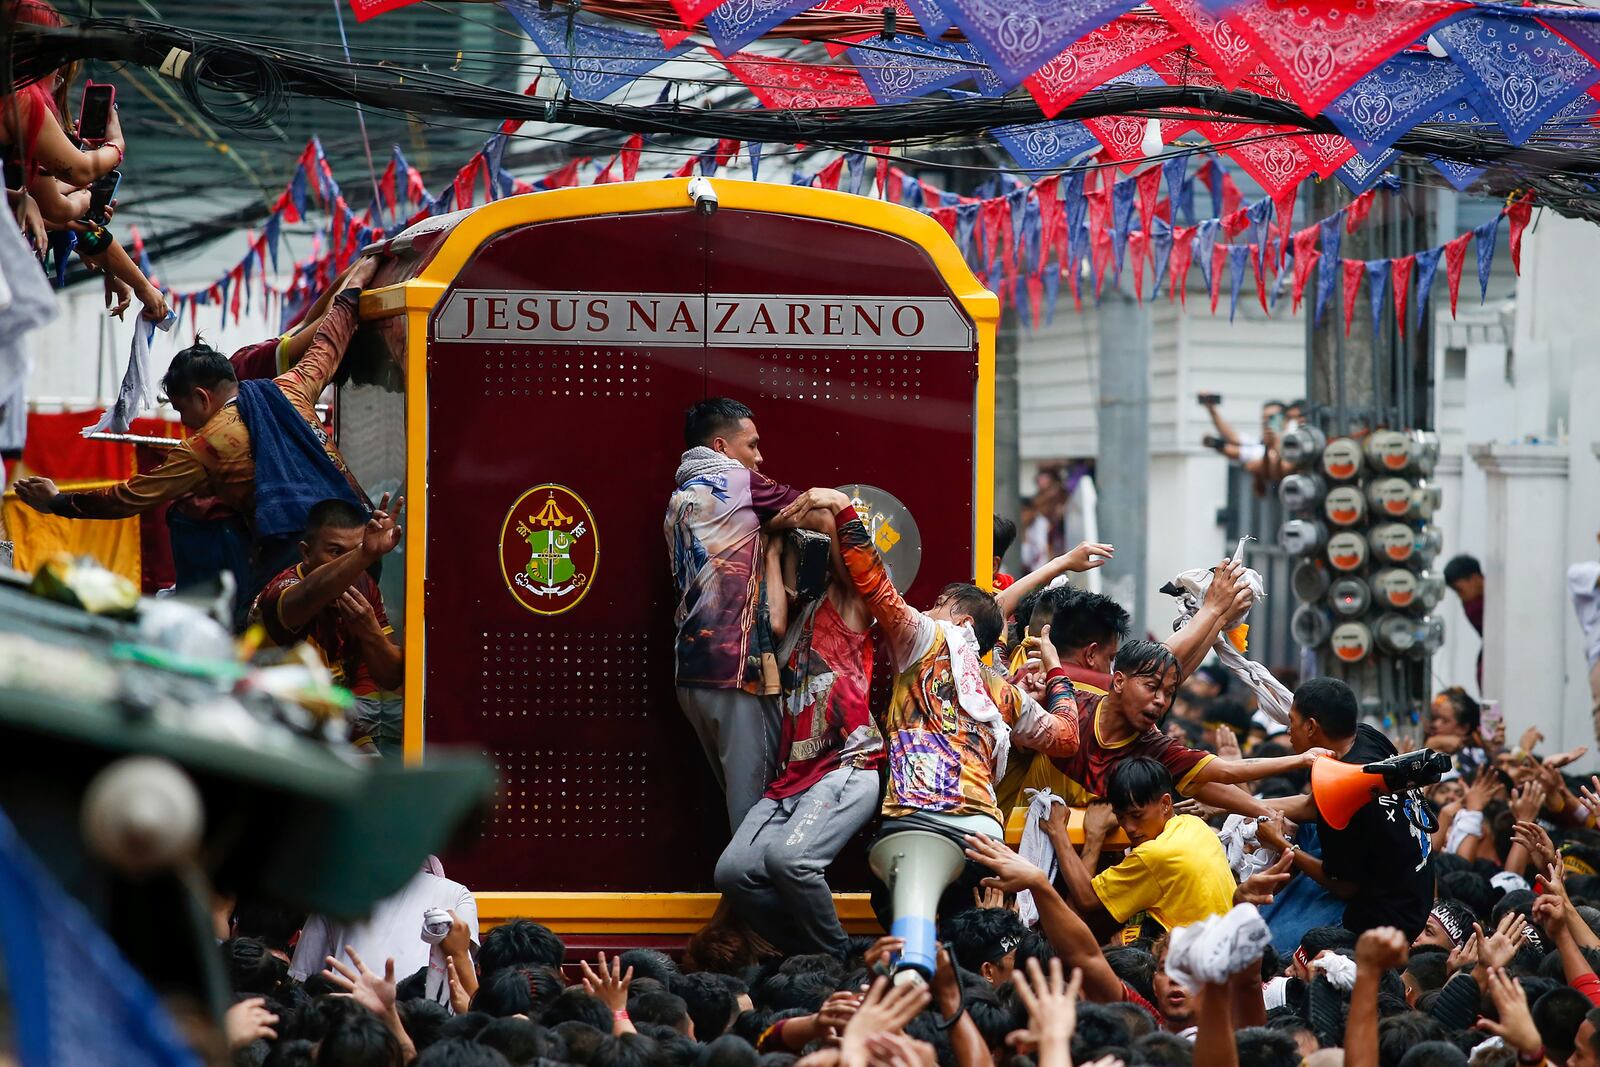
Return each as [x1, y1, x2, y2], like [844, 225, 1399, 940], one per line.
[434, 290, 976, 350]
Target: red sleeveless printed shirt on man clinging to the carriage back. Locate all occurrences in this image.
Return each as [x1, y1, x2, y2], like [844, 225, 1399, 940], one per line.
[766, 597, 883, 800]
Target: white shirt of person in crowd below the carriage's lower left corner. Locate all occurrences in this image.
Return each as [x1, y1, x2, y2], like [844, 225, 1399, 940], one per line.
[290, 870, 478, 1008]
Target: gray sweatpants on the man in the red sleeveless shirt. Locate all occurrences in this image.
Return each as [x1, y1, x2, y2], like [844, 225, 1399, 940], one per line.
[717, 766, 878, 957]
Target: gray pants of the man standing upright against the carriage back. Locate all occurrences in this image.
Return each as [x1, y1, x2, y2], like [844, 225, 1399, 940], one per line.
[678, 686, 779, 830]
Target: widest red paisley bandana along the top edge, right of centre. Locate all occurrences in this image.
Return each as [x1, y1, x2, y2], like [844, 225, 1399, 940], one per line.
[1229, 0, 1467, 115]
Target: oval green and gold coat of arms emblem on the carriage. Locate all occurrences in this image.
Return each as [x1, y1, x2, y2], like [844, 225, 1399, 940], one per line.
[499, 483, 600, 614]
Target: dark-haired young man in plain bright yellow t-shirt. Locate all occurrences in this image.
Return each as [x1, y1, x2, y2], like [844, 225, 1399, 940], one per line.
[1056, 757, 1235, 929]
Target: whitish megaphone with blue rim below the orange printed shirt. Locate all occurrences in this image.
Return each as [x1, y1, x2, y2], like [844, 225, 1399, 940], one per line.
[867, 830, 966, 985]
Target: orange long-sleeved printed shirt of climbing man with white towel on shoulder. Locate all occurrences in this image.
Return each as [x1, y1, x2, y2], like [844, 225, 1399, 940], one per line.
[838, 507, 1078, 825]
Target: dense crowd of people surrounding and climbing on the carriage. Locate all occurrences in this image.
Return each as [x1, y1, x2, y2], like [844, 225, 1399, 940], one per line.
[12, 0, 1600, 1067]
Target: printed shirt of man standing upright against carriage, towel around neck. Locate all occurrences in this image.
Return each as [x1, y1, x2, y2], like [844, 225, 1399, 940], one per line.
[664, 450, 798, 693]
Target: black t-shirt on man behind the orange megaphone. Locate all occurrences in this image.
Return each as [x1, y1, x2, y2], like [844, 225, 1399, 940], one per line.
[1318, 723, 1434, 941]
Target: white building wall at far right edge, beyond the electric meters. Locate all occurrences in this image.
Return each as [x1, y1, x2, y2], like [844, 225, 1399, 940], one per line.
[1434, 213, 1600, 768]
